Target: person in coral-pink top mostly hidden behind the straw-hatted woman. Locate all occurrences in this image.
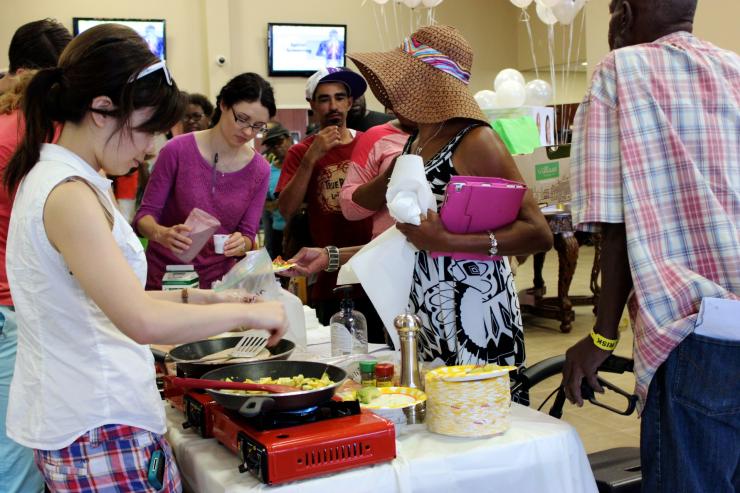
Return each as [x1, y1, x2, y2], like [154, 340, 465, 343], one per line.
[339, 117, 416, 238]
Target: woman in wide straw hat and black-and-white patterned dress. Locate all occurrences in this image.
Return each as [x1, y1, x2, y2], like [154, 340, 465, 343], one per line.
[348, 26, 552, 398]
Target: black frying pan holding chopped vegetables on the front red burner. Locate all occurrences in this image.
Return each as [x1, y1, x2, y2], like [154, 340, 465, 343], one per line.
[202, 360, 347, 417]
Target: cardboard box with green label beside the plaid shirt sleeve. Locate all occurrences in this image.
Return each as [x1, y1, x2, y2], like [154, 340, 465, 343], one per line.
[514, 144, 570, 206]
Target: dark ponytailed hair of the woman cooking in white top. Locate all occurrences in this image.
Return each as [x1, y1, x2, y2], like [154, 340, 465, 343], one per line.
[3, 24, 185, 193]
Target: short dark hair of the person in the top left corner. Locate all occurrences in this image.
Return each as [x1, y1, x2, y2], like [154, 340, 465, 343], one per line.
[8, 19, 72, 74]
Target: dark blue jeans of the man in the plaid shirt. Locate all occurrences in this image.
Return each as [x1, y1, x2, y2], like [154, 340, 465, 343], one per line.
[640, 334, 740, 493]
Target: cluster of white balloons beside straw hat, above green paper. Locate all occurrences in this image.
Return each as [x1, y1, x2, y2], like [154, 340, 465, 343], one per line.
[474, 67, 552, 110]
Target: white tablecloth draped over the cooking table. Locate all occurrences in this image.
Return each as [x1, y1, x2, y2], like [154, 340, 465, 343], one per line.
[167, 404, 597, 493]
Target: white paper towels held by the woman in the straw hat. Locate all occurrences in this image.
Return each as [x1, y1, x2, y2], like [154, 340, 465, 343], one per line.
[337, 154, 437, 348]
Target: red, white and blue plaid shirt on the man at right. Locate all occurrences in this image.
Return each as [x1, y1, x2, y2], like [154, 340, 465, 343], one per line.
[571, 32, 740, 403]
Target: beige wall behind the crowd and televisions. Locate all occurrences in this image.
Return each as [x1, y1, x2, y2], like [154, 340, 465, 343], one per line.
[0, 0, 740, 108]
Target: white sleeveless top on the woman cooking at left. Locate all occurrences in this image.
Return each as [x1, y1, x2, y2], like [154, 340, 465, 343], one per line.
[7, 144, 166, 450]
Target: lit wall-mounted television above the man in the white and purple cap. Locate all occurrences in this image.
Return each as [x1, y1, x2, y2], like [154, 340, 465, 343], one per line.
[267, 23, 347, 77]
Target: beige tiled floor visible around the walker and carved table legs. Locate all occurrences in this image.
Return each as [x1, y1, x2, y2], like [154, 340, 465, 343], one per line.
[516, 247, 640, 453]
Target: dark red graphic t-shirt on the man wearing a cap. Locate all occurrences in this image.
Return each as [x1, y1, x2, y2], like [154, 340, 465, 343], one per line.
[275, 132, 372, 300]
